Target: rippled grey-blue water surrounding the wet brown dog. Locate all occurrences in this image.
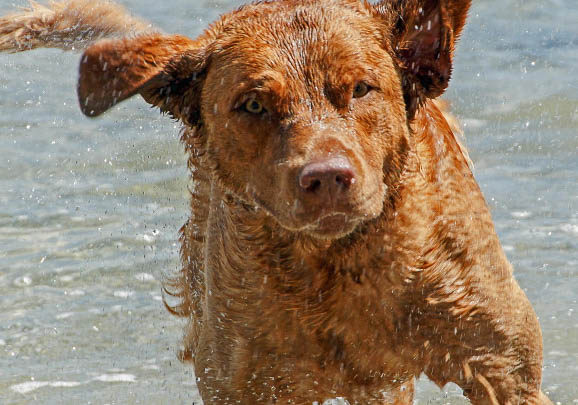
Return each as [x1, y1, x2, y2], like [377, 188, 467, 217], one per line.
[0, 0, 578, 404]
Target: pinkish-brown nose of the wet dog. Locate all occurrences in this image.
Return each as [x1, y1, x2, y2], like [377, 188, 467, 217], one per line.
[299, 157, 355, 196]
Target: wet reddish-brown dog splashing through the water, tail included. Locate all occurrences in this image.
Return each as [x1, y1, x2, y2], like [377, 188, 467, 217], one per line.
[0, 0, 550, 405]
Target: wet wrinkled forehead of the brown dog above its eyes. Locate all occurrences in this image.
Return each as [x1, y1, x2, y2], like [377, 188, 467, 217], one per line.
[207, 3, 385, 83]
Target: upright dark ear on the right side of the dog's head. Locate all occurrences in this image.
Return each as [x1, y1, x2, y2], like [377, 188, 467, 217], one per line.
[375, 0, 471, 115]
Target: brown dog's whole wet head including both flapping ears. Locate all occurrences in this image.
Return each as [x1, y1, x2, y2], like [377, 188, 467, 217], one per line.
[79, 0, 470, 239]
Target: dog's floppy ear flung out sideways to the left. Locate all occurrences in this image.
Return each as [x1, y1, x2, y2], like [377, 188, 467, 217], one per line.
[78, 34, 208, 126]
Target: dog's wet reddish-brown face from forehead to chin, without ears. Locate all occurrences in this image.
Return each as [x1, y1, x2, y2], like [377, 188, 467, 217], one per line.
[201, 4, 409, 238]
